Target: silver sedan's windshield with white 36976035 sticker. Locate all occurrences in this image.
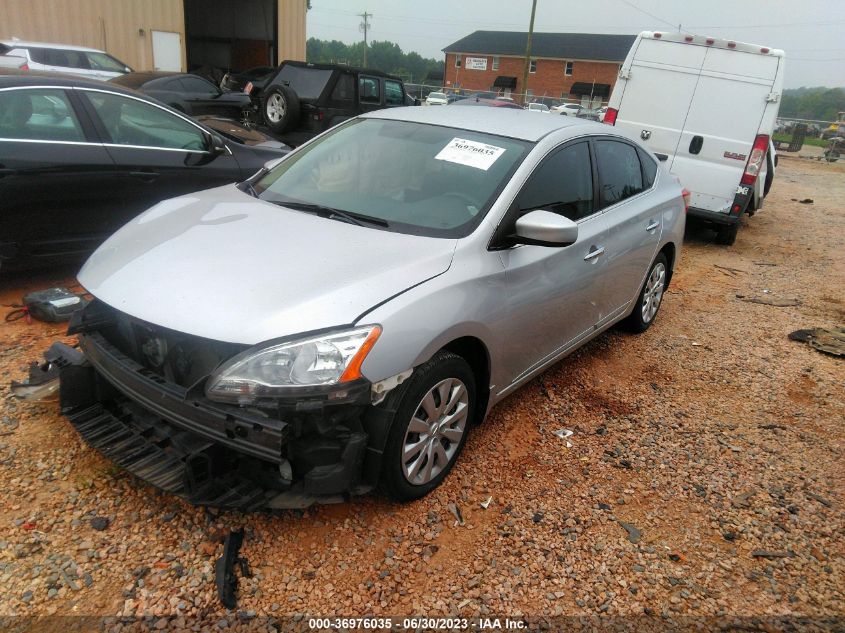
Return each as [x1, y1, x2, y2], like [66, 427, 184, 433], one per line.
[254, 119, 532, 238]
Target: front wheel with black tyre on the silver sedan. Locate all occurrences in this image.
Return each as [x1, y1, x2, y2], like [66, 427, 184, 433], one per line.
[381, 351, 476, 501]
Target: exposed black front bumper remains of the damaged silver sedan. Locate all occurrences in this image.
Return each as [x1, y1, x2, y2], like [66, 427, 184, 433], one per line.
[53, 324, 387, 510]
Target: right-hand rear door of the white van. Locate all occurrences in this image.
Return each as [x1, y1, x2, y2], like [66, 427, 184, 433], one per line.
[668, 46, 780, 213]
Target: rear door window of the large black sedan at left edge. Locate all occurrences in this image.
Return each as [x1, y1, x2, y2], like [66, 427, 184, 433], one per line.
[0, 88, 85, 142]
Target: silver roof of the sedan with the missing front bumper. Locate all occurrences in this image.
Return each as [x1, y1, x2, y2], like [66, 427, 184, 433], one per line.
[362, 106, 592, 142]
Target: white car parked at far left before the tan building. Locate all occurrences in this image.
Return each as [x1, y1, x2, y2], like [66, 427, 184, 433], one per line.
[0, 39, 132, 81]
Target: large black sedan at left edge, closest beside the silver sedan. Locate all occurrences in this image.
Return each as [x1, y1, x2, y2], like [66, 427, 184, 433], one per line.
[0, 69, 286, 267]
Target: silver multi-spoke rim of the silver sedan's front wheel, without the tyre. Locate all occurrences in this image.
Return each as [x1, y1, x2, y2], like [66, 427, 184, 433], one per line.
[402, 378, 469, 486]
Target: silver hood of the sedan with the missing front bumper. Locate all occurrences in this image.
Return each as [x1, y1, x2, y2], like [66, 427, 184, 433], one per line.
[79, 185, 457, 345]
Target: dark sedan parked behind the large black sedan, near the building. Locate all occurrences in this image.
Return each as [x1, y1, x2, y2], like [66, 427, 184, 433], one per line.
[109, 72, 253, 118]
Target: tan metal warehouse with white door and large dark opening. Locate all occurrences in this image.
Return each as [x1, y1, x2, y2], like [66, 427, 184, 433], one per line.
[0, 0, 307, 71]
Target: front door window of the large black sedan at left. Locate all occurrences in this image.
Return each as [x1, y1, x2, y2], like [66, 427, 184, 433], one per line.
[84, 90, 207, 152]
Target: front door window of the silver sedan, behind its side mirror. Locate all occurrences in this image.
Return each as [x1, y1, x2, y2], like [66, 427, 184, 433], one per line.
[517, 142, 595, 222]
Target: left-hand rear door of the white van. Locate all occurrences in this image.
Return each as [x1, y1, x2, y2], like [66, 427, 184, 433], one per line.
[616, 38, 707, 163]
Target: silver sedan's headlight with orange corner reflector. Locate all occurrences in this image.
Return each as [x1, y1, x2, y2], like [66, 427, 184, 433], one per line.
[205, 325, 381, 404]
